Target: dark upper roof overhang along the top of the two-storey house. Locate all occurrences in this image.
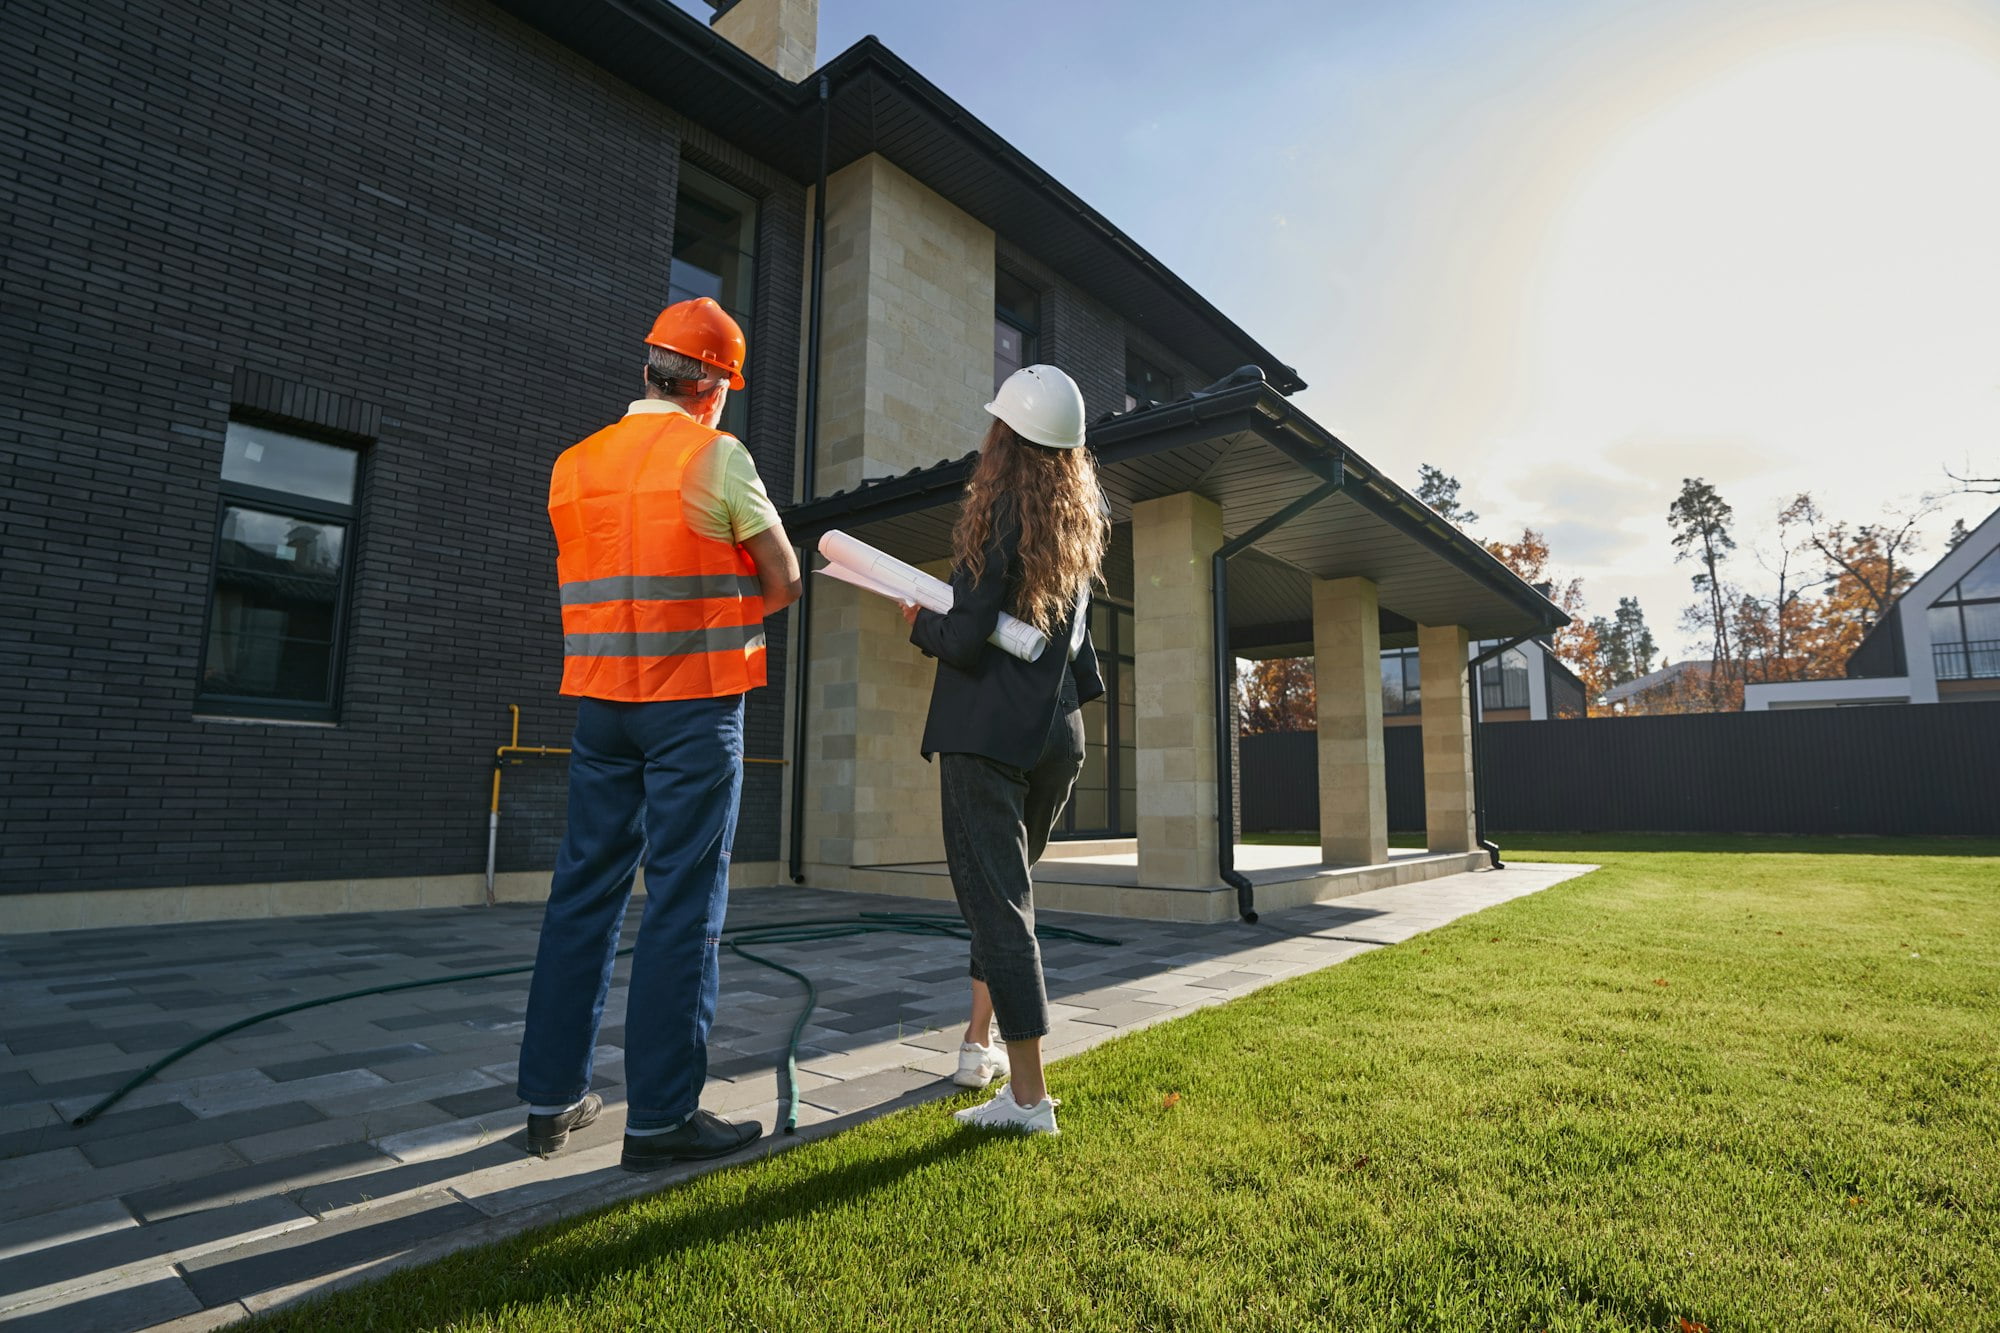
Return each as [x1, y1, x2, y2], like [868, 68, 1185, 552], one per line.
[480, 0, 1306, 392]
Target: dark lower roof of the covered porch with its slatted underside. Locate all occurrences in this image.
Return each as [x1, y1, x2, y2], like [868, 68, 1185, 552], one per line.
[784, 382, 1568, 656]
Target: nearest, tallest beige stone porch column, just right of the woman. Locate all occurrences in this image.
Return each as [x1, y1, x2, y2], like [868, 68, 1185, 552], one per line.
[1132, 490, 1222, 889]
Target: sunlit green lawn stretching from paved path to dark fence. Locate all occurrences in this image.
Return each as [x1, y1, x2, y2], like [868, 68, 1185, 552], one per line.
[260, 839, 2000, 1333]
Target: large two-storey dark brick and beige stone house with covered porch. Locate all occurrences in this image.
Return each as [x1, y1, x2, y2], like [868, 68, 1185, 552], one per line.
[0, 0, 1562, 931]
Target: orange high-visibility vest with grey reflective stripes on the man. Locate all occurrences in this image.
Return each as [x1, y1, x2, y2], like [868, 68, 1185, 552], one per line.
[548, 412, 764, 703]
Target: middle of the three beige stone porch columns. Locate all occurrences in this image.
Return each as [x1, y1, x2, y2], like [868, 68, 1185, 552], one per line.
[1312, 578, 1388, 865]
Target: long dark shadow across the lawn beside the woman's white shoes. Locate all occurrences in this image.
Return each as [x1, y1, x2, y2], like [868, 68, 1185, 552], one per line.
[266, 1115, 1000, 1329]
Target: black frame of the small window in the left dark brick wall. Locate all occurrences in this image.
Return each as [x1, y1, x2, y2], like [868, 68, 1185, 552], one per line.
[192, 412, 370, 725]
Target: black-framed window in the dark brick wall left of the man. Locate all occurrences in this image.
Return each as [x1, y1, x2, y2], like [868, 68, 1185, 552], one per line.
[196, 420, 360, 723]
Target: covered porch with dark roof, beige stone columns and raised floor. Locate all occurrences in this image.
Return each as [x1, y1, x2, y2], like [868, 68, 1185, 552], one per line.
[786, 372, 1564, 921]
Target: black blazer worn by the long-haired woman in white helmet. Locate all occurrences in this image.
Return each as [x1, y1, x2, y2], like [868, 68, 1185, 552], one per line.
[910, 506, 1104, 769]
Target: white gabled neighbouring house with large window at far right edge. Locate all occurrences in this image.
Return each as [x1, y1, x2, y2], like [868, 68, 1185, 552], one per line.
[1744, 508, 2000, 713]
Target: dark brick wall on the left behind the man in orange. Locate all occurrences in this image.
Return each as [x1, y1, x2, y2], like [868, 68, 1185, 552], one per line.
[0, 0, 804, 893]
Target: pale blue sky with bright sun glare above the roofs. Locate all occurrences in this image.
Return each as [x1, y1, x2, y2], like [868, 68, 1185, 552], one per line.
[692, 0, 2000, 658]
